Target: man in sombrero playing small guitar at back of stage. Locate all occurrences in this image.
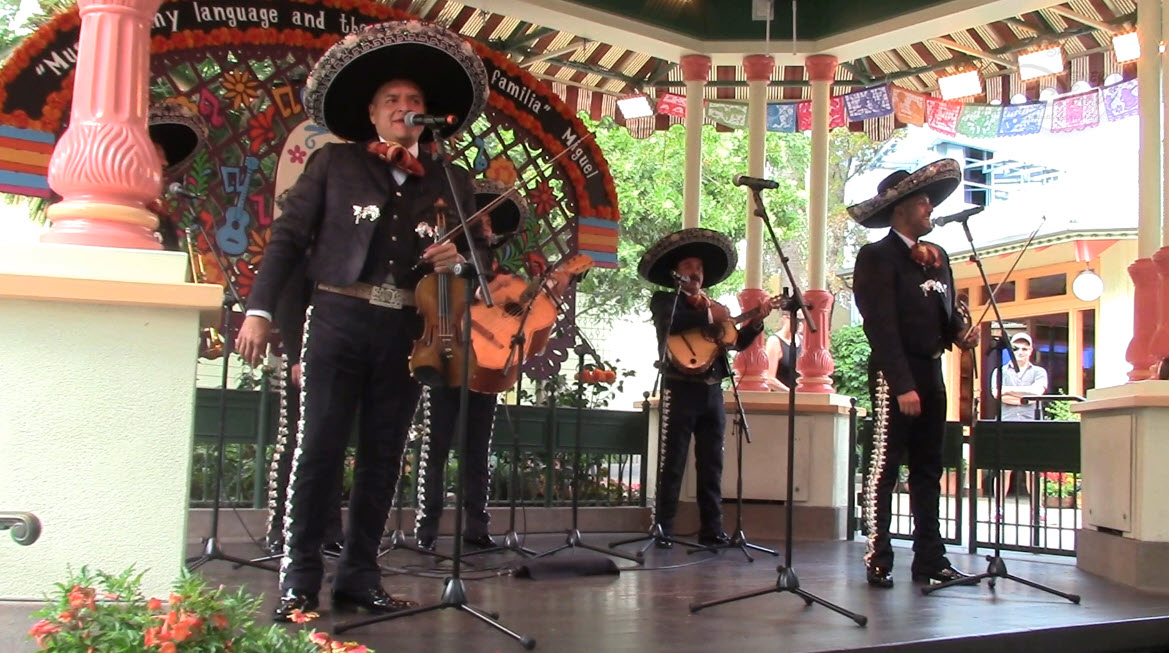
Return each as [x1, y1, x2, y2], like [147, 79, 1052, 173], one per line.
[637, 228, 770, 548]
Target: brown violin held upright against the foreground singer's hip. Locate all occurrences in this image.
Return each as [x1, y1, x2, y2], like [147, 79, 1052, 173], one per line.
[410, 199, 477, 388]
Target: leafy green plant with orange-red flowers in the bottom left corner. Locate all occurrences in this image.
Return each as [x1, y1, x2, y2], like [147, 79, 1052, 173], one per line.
[28, 567, 369, 653]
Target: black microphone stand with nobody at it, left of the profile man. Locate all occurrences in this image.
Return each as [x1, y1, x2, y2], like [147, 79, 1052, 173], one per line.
[690, 187, 869, 626]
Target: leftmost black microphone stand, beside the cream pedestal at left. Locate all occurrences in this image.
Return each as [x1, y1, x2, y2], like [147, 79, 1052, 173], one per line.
[186, 218, 277, 571]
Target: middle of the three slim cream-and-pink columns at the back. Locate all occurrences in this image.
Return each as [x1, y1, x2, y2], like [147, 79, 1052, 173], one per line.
[734, 55, 775, 393]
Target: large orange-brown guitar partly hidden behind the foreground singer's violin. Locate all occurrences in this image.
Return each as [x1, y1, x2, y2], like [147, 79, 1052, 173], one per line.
[471, 253, 594, 393]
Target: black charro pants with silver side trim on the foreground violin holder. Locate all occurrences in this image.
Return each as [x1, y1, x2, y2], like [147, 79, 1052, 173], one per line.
[281, 291, 421, 592]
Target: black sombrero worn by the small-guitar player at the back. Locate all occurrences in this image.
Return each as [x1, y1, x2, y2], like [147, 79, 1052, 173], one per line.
[637, 227, 739, 287]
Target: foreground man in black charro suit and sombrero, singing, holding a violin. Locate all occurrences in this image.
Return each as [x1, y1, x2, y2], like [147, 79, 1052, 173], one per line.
[238, 21, 487, 620]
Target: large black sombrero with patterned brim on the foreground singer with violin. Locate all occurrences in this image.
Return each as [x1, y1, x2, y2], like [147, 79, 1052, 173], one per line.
[304, 21, 487, 141]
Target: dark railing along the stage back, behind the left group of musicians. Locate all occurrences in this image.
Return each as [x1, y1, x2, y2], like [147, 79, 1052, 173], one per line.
[191, 389, 648, 508]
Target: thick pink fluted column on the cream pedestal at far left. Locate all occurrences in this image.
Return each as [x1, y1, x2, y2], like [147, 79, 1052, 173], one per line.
[41, 0, 162, 249]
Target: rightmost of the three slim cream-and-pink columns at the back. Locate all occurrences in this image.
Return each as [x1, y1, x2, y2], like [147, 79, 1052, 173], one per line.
[796, 55, 838, 393]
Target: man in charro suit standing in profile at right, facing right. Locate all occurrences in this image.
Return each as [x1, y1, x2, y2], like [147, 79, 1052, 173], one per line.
[849, 159, 978, 588]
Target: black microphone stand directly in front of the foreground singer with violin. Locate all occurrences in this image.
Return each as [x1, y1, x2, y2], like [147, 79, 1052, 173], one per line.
[333, 128, 535, 651]
